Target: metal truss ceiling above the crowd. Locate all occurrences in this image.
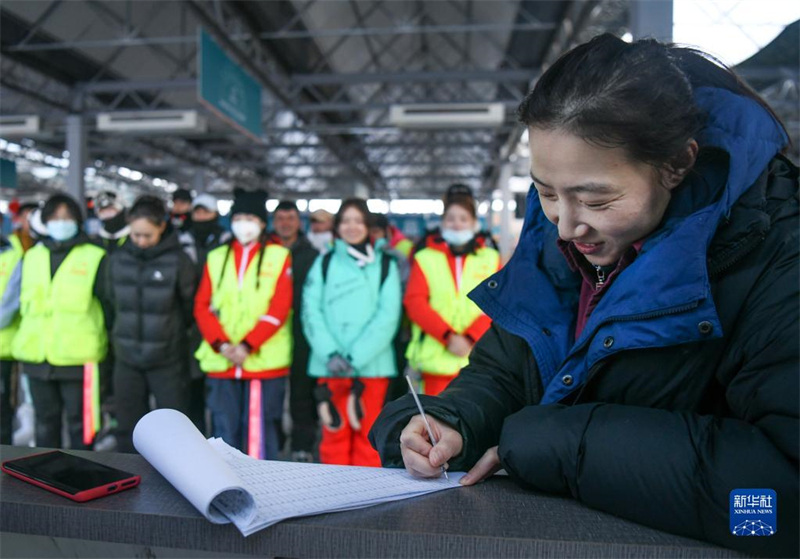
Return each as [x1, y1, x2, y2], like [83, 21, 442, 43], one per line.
[0, 0, 627, 199]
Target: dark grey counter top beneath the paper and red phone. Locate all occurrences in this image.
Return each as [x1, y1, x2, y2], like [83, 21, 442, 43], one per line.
[0, 446, 742, 557]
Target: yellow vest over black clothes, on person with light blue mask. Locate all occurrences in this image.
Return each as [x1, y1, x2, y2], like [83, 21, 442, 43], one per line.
[12, 243, 108, 367]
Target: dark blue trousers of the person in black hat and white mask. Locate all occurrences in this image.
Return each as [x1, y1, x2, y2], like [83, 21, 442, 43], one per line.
[206, 377, 286, 460]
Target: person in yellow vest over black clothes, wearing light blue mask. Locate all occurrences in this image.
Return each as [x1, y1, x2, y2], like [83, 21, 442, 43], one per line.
[0, 194, 110, 449]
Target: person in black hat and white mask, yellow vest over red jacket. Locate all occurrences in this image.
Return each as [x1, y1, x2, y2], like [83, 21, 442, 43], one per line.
[194, 189, 292, 460]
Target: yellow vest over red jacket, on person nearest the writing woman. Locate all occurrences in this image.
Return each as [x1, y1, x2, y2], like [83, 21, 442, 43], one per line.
[406, 247, 500, 375]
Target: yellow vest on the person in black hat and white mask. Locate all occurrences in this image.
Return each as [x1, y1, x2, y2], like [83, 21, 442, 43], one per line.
[195, 244, 292, 376]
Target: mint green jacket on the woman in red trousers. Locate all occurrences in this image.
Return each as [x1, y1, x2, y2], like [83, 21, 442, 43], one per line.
[301, 239, 402, 378]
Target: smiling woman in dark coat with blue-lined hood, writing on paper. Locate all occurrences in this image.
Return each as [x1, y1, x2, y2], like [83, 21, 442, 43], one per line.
[370, 35, 800, 556]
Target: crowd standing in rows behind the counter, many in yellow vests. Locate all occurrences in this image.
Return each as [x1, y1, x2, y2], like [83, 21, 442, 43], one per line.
[0, 185, 500, 466]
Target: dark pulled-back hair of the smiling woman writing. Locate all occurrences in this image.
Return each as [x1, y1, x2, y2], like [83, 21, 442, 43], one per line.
[518, 33, 780, 175]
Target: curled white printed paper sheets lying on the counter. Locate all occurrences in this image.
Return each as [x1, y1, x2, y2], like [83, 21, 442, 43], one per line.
[133, 409, 464, 536]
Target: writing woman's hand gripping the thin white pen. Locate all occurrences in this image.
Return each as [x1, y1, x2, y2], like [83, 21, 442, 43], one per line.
[400, 415, 464, 478]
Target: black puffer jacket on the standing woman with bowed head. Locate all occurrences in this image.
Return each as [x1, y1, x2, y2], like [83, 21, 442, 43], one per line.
[109, 229, 196, 367]
